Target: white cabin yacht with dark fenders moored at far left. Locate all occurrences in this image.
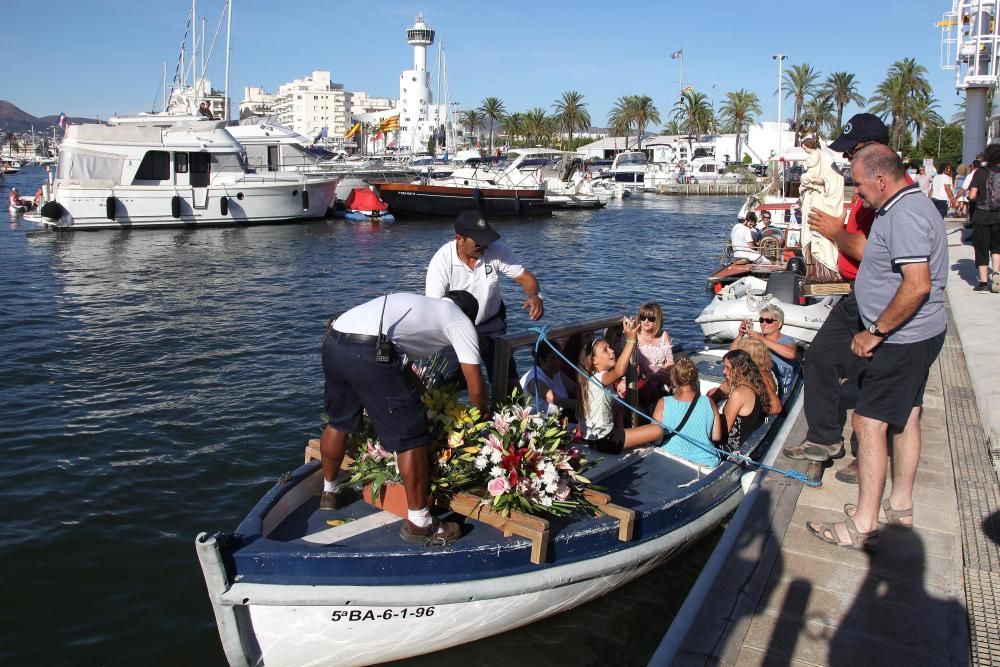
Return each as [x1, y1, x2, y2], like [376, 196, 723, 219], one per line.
[28, 120, 338, 229]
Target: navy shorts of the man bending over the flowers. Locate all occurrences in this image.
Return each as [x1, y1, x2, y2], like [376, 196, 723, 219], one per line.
[323, 331, 430, 452]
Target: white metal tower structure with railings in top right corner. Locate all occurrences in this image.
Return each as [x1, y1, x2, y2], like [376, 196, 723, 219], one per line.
[938, 0, 1000, 164]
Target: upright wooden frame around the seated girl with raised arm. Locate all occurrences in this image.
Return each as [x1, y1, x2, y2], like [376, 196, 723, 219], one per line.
[493, 315, 639, 424]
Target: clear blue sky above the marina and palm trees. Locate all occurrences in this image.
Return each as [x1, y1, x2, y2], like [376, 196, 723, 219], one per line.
[0, 0, 960, 125]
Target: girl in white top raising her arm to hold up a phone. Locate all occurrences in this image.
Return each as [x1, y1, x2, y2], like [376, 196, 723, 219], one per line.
[579, 317, 663, 454]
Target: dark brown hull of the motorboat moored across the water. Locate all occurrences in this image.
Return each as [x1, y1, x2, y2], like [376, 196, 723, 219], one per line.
[375, 183, 552, 217]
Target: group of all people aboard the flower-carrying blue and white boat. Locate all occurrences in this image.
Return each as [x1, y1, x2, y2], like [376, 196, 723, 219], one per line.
[320, 211, 797, 545]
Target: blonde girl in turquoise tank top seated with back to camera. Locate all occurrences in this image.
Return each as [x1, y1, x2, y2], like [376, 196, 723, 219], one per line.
[653, 357, 722, 468]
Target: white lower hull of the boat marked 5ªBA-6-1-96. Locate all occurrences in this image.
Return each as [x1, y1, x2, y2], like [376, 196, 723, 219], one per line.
[197, 487, 743, 667]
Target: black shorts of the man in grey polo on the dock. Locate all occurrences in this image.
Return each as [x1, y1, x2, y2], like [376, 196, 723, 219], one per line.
[854, 331, 946, 428]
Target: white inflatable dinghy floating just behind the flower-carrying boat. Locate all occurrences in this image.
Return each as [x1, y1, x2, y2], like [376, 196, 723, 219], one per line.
[695, 271, 841, 343]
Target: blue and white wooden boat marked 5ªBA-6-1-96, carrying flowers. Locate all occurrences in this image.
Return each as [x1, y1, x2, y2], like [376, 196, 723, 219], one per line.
[196, 349, 801, 667]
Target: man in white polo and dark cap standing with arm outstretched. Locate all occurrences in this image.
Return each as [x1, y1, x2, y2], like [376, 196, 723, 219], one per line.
[424, 211, 545, 381]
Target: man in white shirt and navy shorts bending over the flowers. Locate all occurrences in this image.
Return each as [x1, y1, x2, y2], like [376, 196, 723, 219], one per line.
[320, 291, 489, 546]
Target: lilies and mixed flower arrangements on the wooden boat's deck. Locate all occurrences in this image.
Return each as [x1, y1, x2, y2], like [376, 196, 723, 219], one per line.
[348, 354, 594, 516]
